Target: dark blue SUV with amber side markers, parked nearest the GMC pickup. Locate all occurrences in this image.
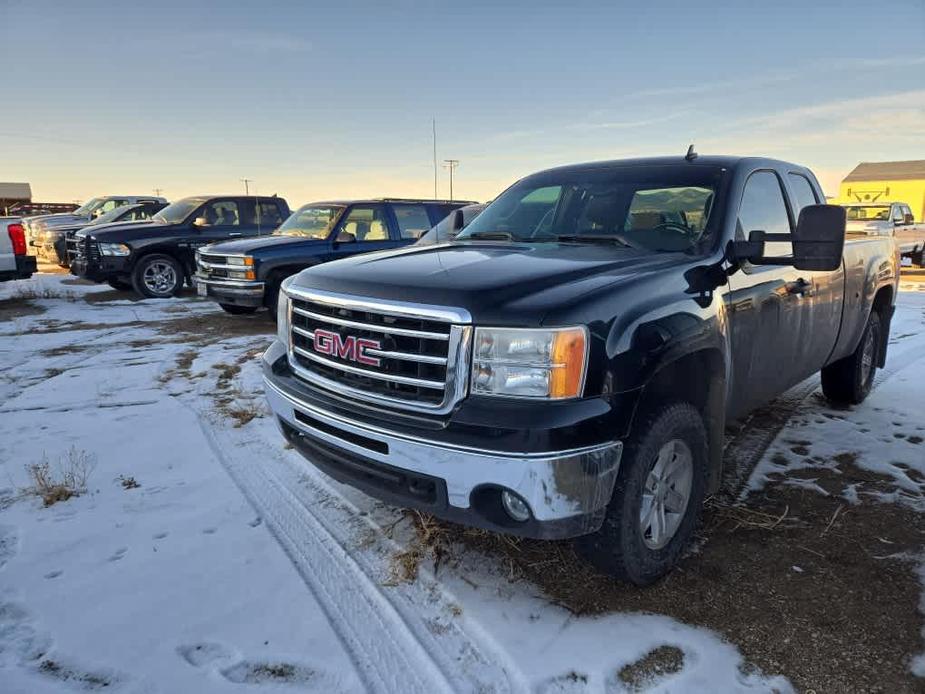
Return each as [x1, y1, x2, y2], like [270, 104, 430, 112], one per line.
[194, 198, 467, 317]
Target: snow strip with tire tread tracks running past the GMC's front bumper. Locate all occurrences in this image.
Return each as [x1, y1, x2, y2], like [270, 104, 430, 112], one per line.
[191, 413, 527, 694]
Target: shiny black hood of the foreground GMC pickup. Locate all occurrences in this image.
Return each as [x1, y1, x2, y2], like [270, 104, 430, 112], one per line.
[294, 243, 695, 325]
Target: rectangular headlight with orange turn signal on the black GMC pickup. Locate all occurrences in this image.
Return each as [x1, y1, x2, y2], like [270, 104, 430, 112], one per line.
[472, 327, 588, 400]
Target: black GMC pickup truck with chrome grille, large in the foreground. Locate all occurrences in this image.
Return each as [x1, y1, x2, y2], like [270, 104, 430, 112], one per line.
[264, 158, 898, 585]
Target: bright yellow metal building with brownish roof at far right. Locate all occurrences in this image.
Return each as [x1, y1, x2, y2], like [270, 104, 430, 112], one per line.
[835, 159, 925, 222]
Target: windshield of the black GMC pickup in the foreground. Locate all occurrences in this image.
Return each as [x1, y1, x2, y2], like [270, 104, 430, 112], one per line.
[457, 165, 723, 251]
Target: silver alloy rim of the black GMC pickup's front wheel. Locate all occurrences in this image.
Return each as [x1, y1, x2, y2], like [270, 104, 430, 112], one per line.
[639, 439, 694, 549]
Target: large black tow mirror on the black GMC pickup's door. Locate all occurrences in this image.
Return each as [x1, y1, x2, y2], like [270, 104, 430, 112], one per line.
[734, 205, 846, 272]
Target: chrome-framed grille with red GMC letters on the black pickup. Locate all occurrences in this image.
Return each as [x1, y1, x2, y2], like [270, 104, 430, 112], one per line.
[286, 287, 472, 413]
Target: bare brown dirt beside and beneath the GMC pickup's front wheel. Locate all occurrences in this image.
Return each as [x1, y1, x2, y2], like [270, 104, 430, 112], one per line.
[408, 460, 925, 692]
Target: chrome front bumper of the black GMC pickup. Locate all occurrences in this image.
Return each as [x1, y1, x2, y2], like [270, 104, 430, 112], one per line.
[265, 368, 623, 539]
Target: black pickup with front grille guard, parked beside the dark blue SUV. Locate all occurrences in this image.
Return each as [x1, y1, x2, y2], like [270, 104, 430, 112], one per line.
[68, 195, 289, 298]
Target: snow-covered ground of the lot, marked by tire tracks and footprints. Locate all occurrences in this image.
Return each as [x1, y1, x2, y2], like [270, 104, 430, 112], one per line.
[0, 275, 925, 693]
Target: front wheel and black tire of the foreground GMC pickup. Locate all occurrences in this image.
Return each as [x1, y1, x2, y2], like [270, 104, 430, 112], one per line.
[577, 402, 709, 586]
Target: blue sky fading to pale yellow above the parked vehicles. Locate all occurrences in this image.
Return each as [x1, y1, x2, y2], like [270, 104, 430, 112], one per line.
[0, 0, 925, 205]
